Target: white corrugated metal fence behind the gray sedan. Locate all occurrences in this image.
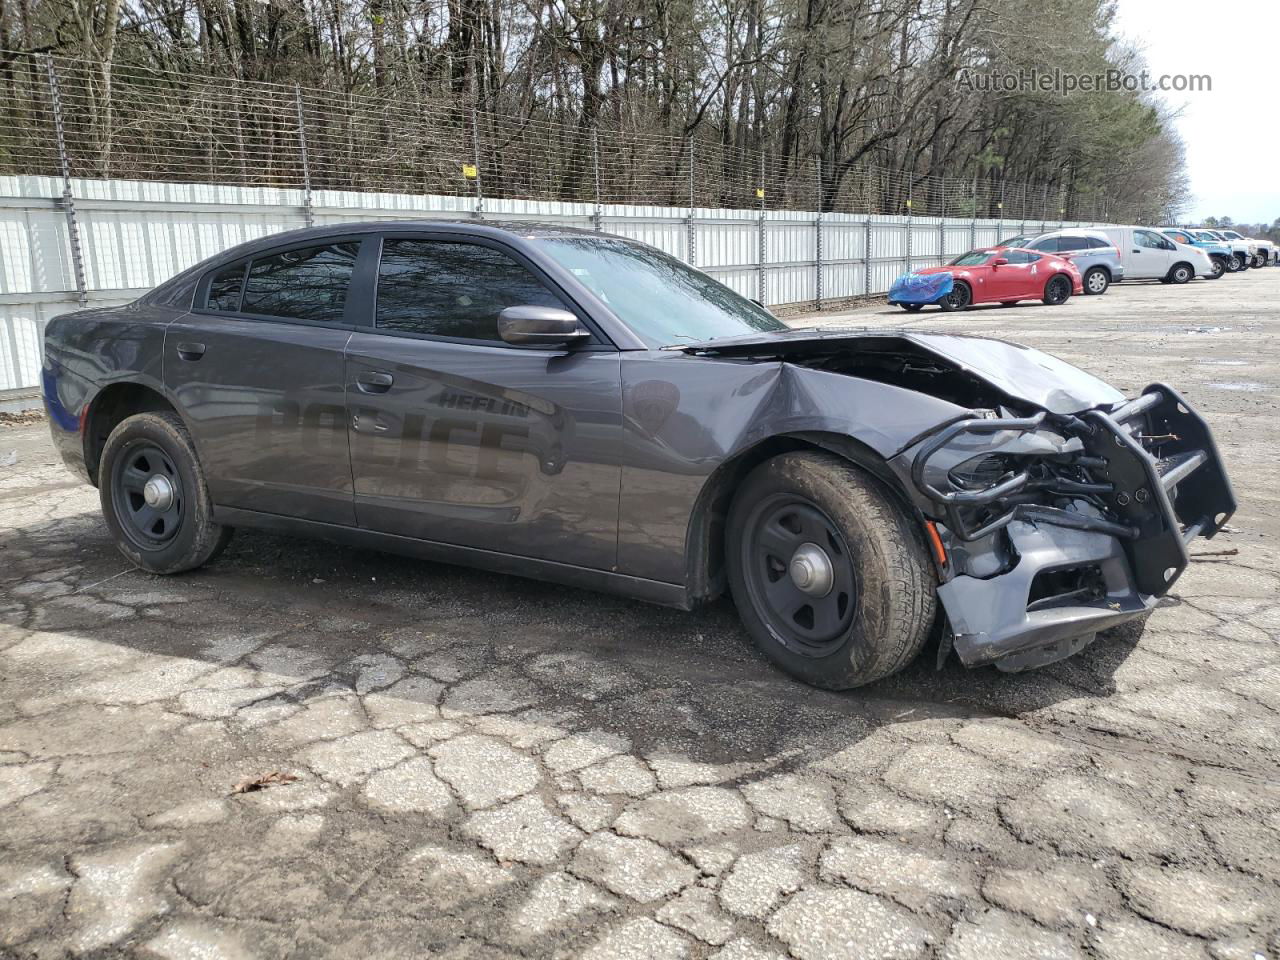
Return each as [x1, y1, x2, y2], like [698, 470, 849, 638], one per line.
[0, 177, 1100, 392]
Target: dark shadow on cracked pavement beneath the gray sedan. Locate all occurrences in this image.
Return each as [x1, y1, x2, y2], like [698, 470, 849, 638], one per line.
[0, 513, 1140, 793]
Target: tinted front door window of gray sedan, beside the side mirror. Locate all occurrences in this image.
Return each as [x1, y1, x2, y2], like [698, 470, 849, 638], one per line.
[375, 239, 564, 343]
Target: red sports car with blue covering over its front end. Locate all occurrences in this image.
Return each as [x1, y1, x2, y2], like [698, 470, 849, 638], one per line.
[888, 247, 1084, 312]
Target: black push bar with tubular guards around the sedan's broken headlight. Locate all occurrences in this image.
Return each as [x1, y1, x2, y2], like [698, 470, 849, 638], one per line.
[911, 384, 1235, 594]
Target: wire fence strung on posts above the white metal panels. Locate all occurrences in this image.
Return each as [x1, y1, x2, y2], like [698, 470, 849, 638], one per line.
[0, 54, 1085, 220]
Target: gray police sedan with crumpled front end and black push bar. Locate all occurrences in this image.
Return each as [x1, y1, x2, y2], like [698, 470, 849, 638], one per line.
[44, 221, 1235, 689]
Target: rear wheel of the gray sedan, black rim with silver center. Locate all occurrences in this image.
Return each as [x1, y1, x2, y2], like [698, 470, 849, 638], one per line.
[97, 412, 232, 573]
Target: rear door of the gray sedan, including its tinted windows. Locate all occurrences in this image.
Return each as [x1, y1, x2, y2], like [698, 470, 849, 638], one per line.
[164, 237, 362, 525]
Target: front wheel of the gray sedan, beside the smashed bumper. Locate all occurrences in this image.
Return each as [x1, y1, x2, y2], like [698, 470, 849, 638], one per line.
[726, 452, 937, 690]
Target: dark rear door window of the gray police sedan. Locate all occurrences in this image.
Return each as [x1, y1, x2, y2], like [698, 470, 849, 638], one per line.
[238, 241, 360, 323]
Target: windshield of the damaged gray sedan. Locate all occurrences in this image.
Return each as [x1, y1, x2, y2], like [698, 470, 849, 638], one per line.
[535, 237, 787, 347]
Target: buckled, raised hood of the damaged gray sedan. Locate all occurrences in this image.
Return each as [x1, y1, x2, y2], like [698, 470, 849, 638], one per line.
[673, 328, 1124, 413]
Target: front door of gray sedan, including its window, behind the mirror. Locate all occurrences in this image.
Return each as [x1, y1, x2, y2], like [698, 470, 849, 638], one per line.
[347, 236, 622, 570]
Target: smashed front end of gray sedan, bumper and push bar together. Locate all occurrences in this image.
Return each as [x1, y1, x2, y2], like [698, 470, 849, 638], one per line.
[899, 384, 1235, 671]
